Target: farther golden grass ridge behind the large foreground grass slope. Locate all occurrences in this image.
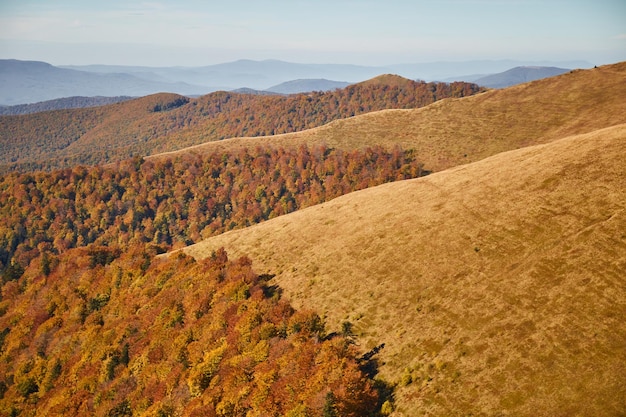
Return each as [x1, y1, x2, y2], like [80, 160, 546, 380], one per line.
[155, 62, 626, 171]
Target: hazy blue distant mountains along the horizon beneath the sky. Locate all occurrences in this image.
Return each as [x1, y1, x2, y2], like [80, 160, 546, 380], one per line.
[0, 60, 593, 105]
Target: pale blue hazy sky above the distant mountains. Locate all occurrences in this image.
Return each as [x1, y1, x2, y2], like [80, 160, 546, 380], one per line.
[0, 0, 626, 66]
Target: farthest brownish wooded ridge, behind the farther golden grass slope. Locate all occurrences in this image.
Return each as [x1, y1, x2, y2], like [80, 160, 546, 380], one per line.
[0, 76, 482, 172]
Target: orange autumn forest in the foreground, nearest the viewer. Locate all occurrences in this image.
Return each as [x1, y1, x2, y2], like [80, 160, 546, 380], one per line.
[0, 245, 382, 417]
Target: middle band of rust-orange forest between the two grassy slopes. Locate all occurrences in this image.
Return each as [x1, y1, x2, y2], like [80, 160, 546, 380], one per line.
[0, 146, 423, 281]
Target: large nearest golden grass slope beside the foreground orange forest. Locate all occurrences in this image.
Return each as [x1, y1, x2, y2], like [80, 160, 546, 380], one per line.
[179, 124, 626, 416]
